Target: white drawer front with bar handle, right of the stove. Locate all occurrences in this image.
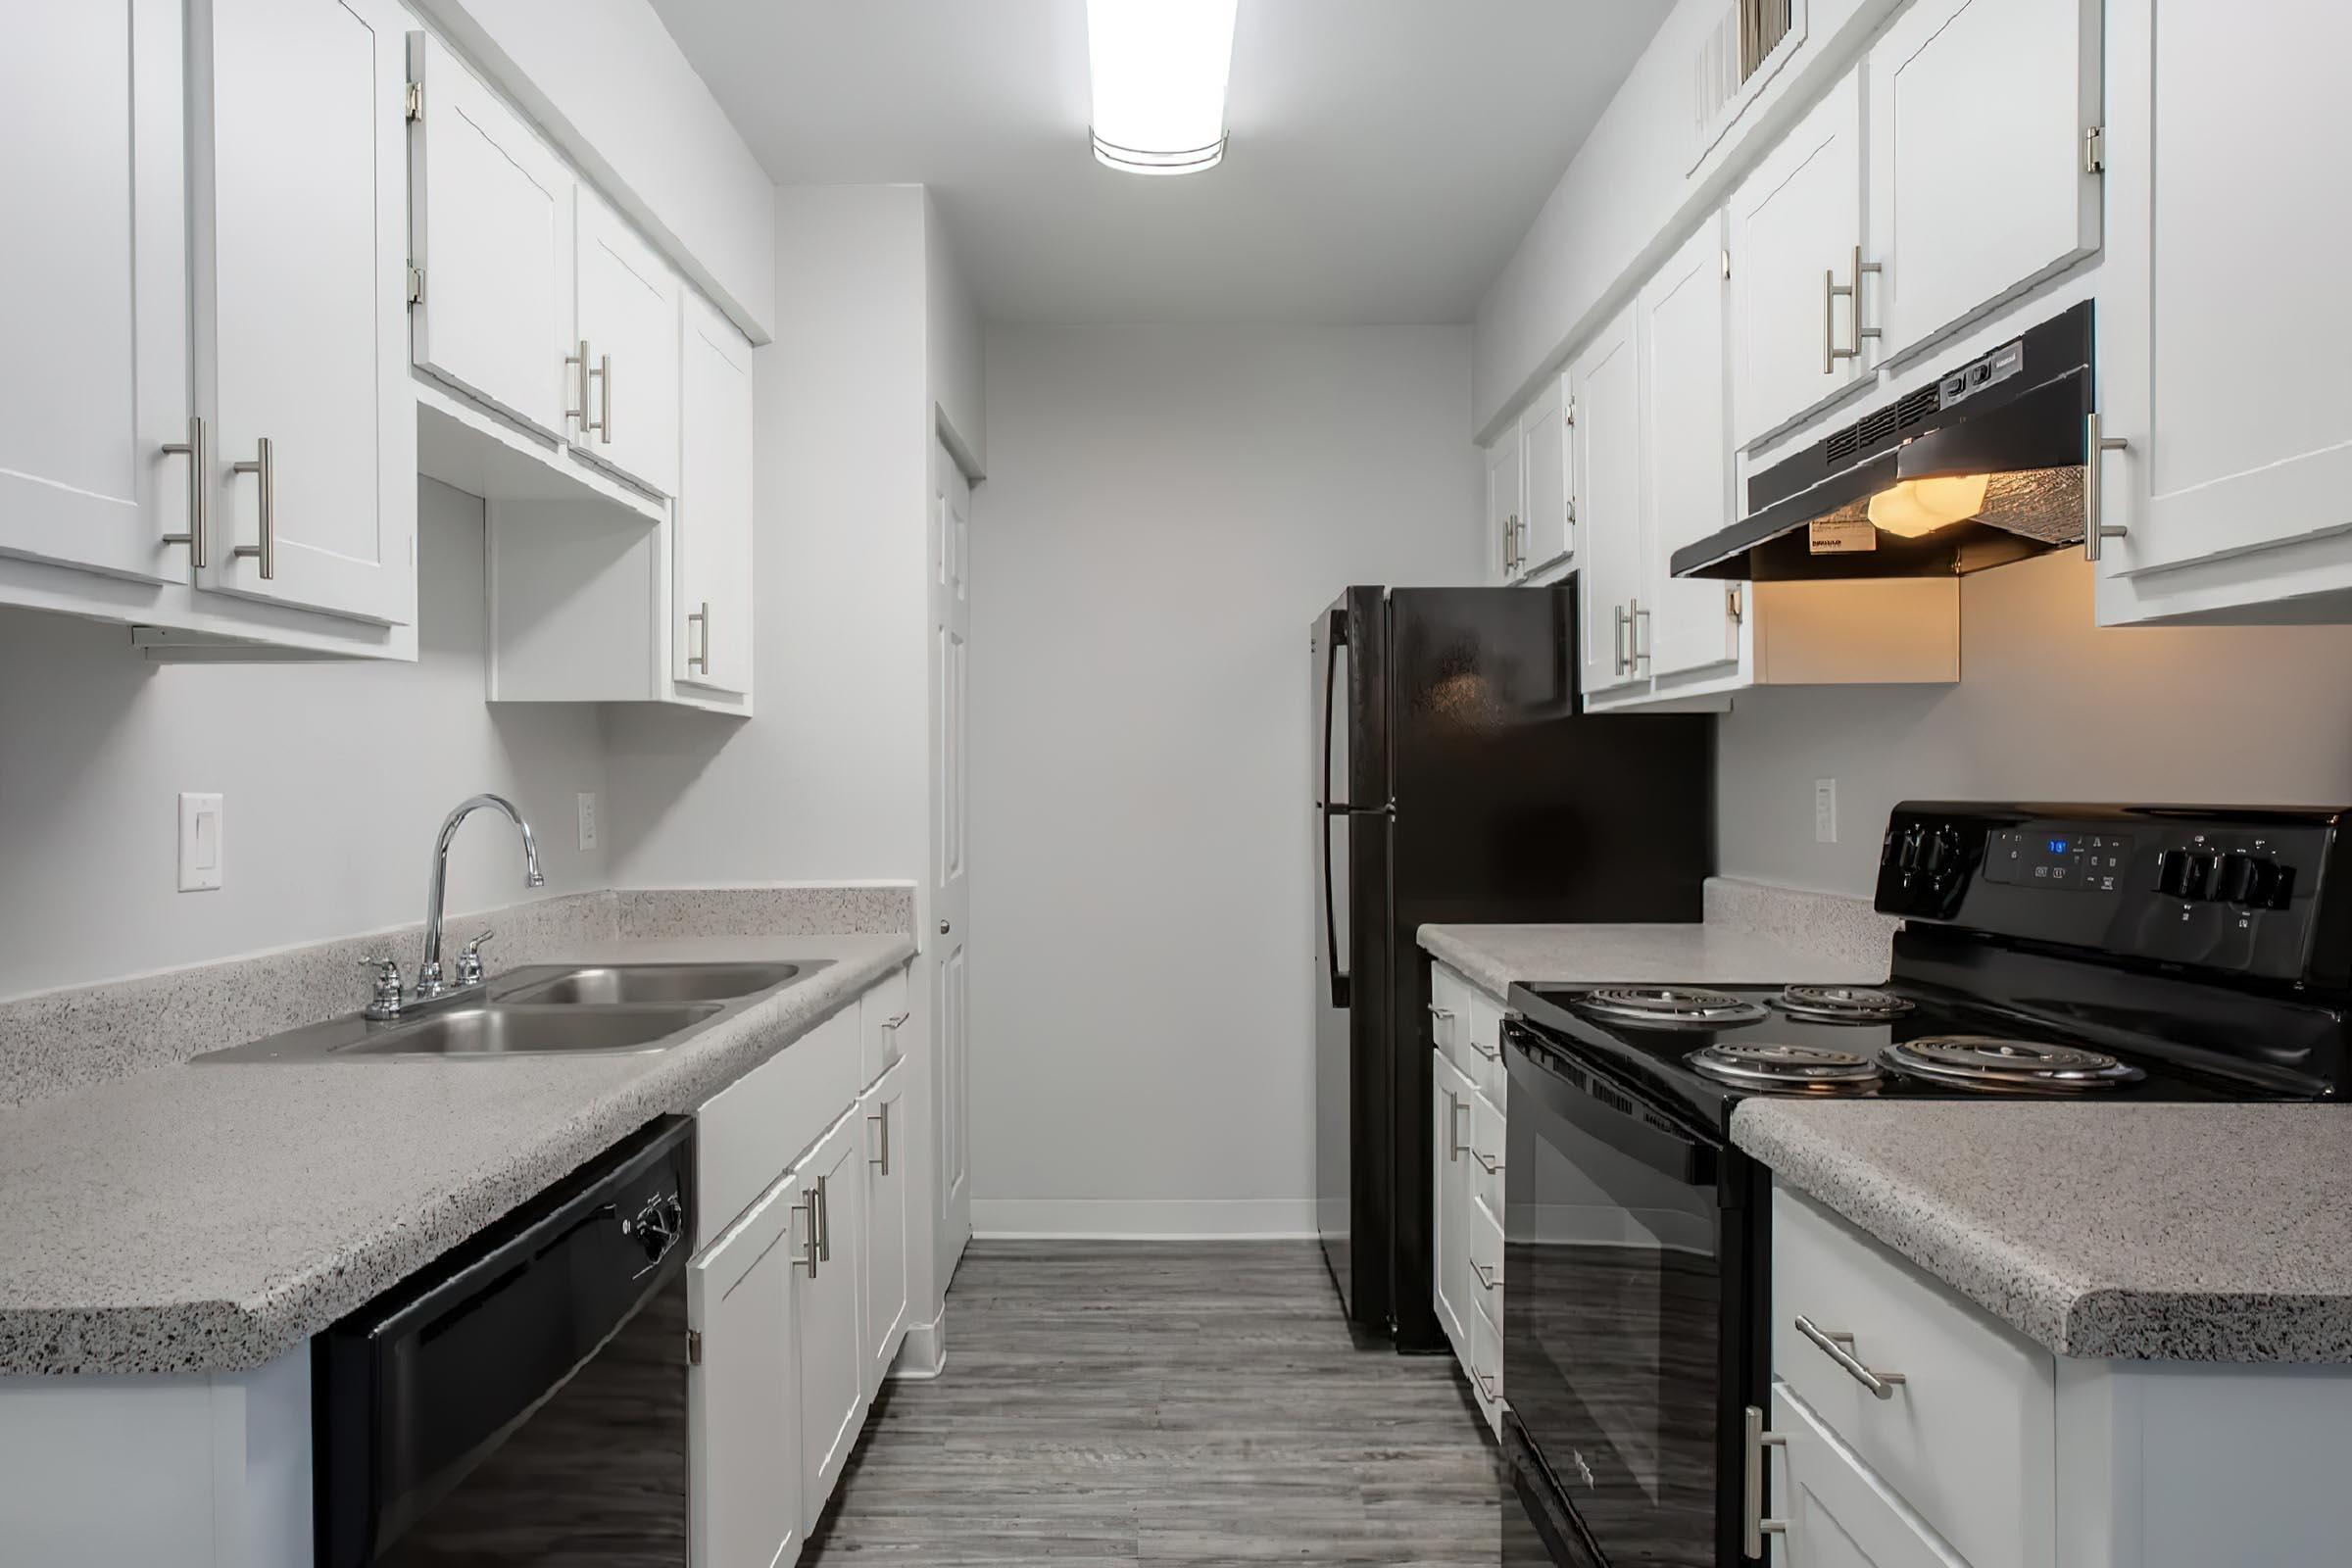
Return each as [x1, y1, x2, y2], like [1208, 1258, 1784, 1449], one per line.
[1771, 1187, 2058, 1568]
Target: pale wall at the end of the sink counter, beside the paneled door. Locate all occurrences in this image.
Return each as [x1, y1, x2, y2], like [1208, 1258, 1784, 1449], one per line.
[607, 186, 931, 886]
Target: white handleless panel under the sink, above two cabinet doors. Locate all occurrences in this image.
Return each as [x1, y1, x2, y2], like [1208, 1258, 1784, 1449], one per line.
[694, 1004, 858, 1250]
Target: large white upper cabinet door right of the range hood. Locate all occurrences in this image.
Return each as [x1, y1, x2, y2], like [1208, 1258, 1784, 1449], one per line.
[2098, 0, 2352, 592]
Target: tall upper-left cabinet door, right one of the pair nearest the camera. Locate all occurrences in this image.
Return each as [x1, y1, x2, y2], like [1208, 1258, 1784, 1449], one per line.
[190, 0, 416, 625]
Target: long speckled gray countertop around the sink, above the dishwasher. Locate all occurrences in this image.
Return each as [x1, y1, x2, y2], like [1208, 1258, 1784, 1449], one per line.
[0, 936, 915, 1373]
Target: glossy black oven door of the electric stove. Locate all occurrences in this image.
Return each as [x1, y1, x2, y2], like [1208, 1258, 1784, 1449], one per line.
[1503, 1022, 1762, 1568]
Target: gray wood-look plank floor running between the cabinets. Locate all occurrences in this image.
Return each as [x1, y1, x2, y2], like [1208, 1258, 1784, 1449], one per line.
[800, 1242, 1500, 1568]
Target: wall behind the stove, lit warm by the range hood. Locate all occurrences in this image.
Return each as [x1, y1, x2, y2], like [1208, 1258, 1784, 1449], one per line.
[1717, 550, 2352, 896]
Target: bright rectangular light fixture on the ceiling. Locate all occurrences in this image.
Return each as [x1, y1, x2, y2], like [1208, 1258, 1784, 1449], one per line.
[1087, 0, 1237, 174]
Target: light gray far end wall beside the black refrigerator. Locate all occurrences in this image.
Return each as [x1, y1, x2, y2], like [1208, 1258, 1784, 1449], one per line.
[971, 326, 1484, 1232]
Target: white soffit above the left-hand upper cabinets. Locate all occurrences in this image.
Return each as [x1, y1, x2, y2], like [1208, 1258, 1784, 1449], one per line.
[414, 0, 776, 343]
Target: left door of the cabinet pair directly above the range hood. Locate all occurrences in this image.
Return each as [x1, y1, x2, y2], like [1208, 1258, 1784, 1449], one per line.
[1731, 73, 1862, 447]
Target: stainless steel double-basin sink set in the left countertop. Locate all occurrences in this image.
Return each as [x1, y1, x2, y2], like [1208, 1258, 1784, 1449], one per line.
[195, 959, 830, 1062]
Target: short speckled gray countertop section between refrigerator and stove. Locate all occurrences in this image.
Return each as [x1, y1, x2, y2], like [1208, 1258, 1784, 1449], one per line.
[1421, 877, 1895, 997]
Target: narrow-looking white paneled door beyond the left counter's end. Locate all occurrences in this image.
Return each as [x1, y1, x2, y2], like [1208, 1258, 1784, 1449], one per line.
[924, 442, 971, 1291]
